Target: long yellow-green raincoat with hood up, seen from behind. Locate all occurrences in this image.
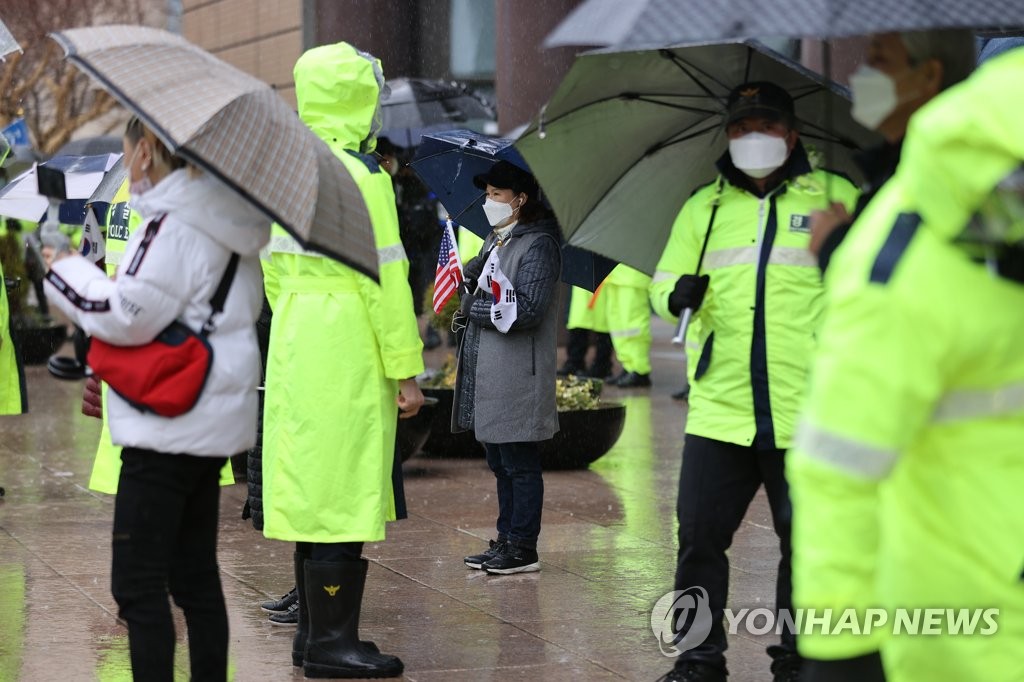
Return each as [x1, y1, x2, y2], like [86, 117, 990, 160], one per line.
[263, 43, 423, 543]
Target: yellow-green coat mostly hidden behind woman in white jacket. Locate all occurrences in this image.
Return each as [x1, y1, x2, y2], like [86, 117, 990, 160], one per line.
[89, 178, 234, 495]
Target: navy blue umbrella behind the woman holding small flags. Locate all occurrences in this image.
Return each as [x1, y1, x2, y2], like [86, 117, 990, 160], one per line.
[410, 130, 617, 291]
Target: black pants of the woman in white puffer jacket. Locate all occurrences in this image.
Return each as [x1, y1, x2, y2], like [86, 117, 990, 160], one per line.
[111, 447, 227, 682]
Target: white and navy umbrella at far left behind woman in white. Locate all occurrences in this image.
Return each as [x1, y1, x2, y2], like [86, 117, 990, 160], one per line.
[0, 154, 124, 225]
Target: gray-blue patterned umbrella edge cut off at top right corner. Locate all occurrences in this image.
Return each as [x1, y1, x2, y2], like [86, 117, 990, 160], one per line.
[545, 0, 1024, 49]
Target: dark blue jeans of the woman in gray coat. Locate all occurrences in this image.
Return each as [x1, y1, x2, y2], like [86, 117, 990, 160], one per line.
[483, 442, 544, 549]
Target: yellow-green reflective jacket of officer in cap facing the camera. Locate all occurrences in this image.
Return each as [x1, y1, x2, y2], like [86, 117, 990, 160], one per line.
[650, 146, 857, 449]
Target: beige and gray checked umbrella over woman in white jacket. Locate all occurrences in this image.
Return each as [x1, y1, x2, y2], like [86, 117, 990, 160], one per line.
[52, 26, 377, 278]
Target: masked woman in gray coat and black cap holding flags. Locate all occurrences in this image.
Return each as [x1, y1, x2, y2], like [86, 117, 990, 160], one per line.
[452, 161, 561, 574]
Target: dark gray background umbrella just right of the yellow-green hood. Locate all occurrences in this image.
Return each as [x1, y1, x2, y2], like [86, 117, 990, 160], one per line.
[381, 78, 496, 147]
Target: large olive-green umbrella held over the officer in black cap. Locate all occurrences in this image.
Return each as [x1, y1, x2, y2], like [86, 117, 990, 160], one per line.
[516, 41, 880, 273]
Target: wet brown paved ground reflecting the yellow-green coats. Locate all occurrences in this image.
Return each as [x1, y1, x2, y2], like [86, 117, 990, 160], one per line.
[0, 315, 778, 682]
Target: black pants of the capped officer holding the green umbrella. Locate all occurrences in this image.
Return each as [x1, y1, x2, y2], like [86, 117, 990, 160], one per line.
[676, 435, 797, 669]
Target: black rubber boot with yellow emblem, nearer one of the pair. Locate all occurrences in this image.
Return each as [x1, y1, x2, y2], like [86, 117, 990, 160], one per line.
[299, 559, 404, 678]
